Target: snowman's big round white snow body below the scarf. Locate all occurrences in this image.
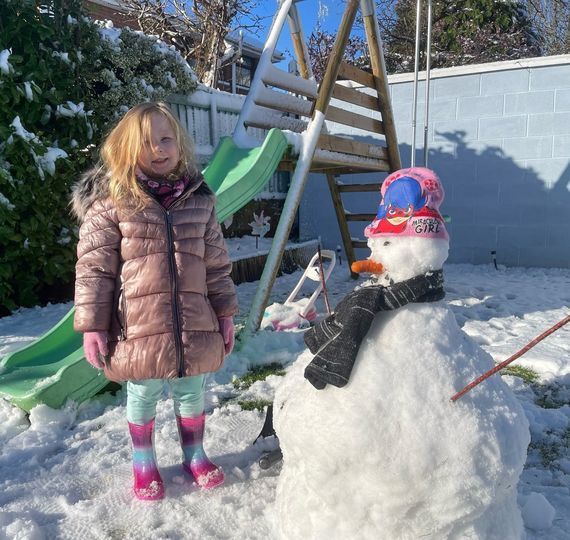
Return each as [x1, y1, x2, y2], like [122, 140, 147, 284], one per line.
[275, 302, 528, 540]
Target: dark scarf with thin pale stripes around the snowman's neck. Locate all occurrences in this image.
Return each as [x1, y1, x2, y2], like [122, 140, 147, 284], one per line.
[305, 270, 445, 390]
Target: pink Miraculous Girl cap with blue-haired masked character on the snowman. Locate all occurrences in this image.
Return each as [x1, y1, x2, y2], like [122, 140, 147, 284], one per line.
[364, 167, 449, 240]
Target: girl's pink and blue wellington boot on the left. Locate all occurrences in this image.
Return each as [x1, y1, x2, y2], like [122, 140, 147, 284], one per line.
[128, 418, 164, 501]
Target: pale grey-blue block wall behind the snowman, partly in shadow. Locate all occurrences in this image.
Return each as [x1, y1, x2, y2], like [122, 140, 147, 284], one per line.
[300, 55, 570, 268]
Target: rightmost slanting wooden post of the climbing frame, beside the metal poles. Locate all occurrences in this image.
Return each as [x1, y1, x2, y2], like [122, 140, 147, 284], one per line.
[361, 0, 402, 171]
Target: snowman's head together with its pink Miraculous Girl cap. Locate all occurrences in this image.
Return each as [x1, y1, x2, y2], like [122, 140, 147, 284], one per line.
[364, 167, 449, 282]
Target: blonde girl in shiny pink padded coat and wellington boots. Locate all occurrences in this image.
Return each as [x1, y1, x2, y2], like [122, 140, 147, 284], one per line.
[73, 103, 237, 500]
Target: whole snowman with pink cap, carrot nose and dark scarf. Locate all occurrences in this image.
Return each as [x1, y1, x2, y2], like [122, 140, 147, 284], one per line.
[274, 168, 530, 540]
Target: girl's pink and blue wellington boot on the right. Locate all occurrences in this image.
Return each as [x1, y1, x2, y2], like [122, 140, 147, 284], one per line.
[176, 413, 224, 489]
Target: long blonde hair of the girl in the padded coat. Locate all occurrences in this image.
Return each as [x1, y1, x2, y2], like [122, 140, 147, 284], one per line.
[100, 102, 198, 213]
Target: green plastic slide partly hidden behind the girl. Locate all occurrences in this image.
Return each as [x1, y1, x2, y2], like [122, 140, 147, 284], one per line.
[0, 129, 287, 412]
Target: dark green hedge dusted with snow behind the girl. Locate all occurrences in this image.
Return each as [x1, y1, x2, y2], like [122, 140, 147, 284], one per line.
[0, 0, 196, 315]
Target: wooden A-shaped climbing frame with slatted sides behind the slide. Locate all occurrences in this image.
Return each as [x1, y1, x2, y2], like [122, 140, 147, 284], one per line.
[234, 0, 401, 340]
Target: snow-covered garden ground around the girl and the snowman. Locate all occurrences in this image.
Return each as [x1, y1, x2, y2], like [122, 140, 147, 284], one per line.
[0, 265, 570, 540]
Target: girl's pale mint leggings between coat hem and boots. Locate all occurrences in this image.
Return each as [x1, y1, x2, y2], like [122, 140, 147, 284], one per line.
[127, 375, 206, 425]
